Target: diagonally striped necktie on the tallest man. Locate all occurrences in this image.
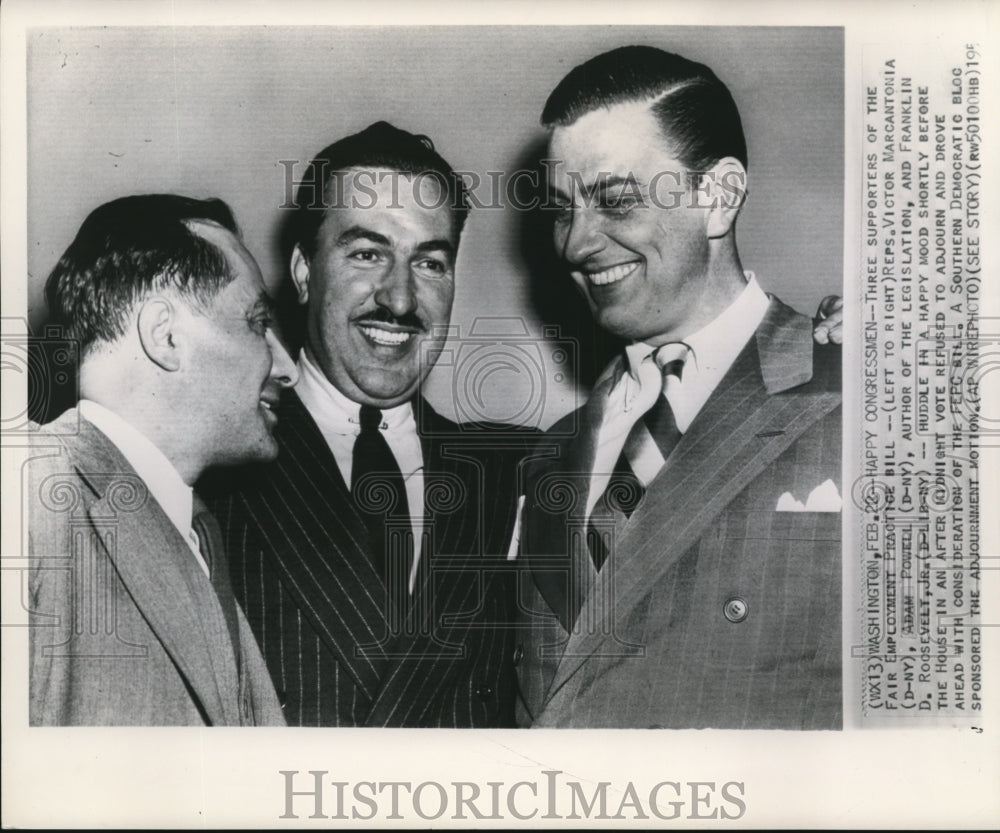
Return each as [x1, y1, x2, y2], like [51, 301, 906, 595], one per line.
[587, 344, 687, 570]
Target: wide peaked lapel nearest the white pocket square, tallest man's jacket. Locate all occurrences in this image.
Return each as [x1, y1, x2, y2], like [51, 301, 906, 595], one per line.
[549, 300, 840, 696]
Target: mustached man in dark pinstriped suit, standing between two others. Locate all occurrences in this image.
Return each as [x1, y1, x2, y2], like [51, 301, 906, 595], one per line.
[213, 122, 524, 727]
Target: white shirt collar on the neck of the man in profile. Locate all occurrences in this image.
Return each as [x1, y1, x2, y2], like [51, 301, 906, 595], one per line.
[79, 399, 209, 576]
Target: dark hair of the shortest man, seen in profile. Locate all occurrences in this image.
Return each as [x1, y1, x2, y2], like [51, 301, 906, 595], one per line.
[45, 194, 239, 355]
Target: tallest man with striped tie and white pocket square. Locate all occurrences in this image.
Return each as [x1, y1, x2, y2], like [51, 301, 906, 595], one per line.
[519, 47, 842, 729]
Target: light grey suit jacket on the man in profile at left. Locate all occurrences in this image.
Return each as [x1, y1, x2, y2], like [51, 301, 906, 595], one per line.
[26, 411, 285, 726]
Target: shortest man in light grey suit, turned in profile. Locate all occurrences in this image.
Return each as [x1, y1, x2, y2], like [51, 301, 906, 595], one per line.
[28, 194, 296, 726]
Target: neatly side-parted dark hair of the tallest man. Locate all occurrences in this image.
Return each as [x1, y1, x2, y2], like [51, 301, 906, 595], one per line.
[542, 46, 747, 171]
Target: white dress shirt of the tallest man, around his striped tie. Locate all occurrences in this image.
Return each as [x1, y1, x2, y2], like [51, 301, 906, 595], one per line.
[587, 272, 769, 517]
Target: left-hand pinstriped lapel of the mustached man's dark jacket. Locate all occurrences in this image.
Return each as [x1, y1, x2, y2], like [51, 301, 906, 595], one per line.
[249, 391, 386, 700]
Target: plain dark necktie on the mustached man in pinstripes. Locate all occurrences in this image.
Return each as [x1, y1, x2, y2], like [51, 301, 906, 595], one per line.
[351, 405, 410, 614]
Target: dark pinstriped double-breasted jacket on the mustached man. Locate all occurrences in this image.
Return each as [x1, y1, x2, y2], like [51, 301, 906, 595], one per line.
[213, 391, 523, 727]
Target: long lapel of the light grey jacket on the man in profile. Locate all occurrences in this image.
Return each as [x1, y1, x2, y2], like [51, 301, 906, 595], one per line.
[74, 420, 240, 725]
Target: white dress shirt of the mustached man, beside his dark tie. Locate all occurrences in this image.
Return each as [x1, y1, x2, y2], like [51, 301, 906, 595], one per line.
[295, 348, 424, 593]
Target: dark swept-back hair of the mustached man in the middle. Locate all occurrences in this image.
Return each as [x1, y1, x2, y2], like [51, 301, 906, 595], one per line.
[290, 121, 469, 258]
